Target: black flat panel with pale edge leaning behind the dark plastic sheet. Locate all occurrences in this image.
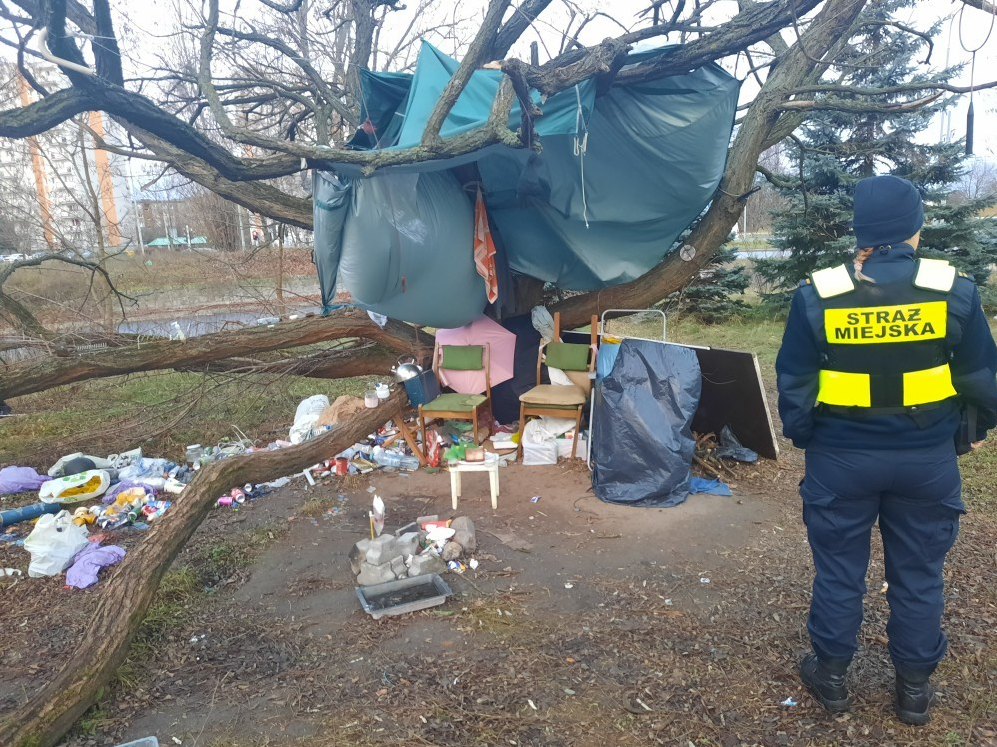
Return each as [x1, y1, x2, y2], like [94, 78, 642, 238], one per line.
[690, 346, 779, 459]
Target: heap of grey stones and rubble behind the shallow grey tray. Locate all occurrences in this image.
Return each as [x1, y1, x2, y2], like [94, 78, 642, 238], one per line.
[350, 517, 476, 586]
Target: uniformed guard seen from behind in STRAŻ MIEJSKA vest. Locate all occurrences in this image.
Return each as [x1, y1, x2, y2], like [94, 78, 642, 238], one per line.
[776, 176, 997, 725]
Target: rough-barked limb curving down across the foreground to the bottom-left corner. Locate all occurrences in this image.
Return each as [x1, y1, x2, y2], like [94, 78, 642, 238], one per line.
[0, 391, 406, 747]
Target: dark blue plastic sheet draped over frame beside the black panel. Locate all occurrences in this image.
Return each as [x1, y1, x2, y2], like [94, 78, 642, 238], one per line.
[591, 340, 702, 508]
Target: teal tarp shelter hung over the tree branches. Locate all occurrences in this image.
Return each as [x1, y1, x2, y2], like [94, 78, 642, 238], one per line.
[314, 43, 739, 327]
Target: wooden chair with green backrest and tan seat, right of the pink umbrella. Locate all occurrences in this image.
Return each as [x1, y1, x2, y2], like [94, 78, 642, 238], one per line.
[518, 315, 599, 459]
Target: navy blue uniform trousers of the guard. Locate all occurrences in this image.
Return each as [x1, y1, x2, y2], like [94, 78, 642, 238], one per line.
[800, 441, 964, 674]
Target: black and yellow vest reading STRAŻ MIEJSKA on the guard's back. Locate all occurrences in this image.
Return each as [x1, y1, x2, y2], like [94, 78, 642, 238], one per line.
[810, 259, 958, 414]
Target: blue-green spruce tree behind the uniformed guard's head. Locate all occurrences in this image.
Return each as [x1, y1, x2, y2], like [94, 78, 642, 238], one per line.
[755, 0, 997, 301]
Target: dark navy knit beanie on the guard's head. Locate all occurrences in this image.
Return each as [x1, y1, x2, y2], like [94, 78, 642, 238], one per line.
[852, 175, 924, 249]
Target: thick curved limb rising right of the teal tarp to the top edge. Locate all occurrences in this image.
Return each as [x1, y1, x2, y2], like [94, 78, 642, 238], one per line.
[551, 0, 867, 324]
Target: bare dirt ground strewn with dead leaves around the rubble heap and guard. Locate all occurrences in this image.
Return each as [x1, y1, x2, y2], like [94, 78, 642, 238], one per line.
[0, 442, 997, 747]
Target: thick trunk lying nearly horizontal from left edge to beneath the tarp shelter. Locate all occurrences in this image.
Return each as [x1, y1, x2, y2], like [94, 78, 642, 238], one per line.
[0, 309, 433, 400]
